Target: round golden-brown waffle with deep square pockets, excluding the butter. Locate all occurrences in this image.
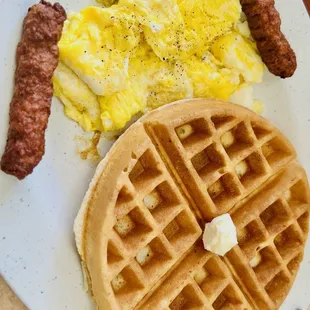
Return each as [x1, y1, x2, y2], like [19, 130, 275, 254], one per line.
[75, 99, 310, 310]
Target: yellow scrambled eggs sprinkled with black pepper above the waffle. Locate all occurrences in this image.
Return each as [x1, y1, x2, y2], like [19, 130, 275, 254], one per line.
[54, 0, 264, 132]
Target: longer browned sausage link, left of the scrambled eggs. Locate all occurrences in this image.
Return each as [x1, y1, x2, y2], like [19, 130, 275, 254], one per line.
[1, 1, 66, 179]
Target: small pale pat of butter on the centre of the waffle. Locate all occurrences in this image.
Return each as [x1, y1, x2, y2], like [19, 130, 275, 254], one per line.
[202, 214, 238, 256]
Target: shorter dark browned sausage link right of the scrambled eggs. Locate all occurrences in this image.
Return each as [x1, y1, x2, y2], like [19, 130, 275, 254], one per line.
[241, 0, 297, 78]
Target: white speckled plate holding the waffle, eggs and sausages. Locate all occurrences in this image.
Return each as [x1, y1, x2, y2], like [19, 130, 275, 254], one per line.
[0, 0, 310, 310]
